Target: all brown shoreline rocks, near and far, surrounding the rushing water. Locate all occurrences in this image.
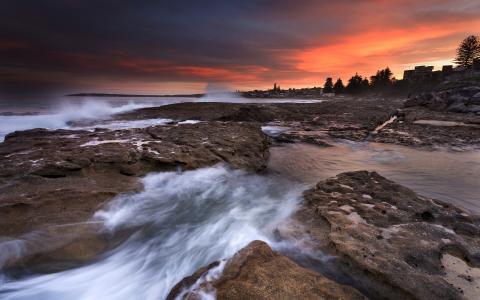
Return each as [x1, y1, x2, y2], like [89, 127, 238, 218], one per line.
[0, 92, 480, 299]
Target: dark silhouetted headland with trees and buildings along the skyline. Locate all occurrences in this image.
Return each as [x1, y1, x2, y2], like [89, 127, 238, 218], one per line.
[71, 35, 480, 99]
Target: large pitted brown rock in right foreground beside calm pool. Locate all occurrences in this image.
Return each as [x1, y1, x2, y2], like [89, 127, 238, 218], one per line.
[280, 171, 480, 299]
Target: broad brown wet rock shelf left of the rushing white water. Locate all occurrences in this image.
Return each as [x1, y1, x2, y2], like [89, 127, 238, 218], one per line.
[0, 122, 268, 266]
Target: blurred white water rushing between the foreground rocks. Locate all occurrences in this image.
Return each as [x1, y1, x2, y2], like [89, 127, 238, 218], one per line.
[0, 165, 303, 300]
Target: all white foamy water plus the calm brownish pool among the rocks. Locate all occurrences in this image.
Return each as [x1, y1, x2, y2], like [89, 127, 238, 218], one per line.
[0, 96, 480, 300]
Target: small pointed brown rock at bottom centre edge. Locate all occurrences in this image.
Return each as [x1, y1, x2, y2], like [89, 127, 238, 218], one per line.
[167, 241, 366, 299]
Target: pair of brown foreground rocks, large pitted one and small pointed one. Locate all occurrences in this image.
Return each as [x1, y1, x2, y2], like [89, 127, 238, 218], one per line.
[170, 171, 480, 300]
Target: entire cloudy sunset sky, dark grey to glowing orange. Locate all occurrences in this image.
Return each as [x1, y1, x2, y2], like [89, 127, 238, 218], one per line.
[0, 0, 480, 96]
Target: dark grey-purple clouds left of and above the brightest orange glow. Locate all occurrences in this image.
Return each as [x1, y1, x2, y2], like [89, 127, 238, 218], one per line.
[0, 0, 480, 95]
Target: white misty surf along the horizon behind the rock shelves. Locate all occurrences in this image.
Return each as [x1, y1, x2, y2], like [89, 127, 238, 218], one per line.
[0, 93, 322, 142]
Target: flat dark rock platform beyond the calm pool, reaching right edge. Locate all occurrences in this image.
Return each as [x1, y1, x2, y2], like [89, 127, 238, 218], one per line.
[117, 96, 480, 148]
